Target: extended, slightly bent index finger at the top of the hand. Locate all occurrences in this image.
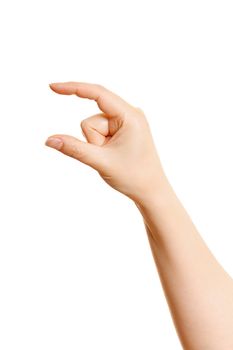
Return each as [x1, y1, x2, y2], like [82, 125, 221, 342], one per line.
[49, 81, 133, 117]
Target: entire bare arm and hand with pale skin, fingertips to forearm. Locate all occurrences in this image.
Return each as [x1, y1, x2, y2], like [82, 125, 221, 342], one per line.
[46, 82, 233, 350]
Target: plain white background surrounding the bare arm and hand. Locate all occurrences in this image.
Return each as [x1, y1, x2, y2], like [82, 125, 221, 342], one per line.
[0, 0, 233, 350]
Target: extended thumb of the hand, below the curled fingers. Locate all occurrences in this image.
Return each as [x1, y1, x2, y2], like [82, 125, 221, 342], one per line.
[45, 135, 106, 171]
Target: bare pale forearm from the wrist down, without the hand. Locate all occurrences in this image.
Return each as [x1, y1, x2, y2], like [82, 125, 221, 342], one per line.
[135, 182, 233, 350]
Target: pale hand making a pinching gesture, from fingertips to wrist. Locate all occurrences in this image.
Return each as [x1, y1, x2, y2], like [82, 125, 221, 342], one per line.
[45, 82, 166, 202]
